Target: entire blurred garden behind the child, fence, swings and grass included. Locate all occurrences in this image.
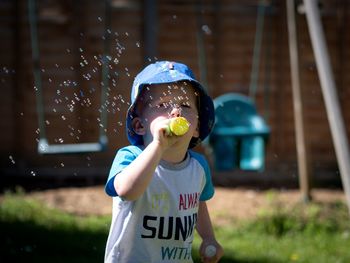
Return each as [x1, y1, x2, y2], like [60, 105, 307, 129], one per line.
[0, 0, 350, 263]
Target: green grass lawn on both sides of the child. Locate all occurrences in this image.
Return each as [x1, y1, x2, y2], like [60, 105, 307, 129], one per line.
[0, 191, 350, 263]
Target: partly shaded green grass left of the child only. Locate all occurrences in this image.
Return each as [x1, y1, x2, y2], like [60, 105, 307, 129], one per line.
[0, 192, 110, 263]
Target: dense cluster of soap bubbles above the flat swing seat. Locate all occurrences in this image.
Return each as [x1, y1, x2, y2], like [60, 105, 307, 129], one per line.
[29, 17, 141, 151]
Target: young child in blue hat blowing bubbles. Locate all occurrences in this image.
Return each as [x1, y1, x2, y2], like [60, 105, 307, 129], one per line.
[105, 61, 223, 263]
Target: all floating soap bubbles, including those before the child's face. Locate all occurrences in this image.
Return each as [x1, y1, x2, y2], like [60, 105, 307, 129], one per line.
[9, 12, 211, 176]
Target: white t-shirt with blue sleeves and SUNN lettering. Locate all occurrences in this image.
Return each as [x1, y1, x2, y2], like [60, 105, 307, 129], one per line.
[105, 146, 214, 263]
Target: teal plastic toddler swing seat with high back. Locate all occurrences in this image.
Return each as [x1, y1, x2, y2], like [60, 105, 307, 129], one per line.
[209, 93, 270, 171]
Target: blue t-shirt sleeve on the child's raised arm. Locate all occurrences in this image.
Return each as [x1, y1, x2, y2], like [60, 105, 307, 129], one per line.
[105, 146, 142, 196]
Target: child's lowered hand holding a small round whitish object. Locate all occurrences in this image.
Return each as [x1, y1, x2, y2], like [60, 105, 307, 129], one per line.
[199, 240, 224, 263]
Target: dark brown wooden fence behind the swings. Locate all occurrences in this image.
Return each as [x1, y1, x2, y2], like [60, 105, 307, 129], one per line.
[0, 0, 350, 193]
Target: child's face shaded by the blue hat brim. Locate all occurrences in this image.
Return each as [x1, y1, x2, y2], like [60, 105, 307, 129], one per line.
[137, 82, 199, 144]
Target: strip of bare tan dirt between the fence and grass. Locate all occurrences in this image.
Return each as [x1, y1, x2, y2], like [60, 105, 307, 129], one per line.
[28, 186, 345, 222]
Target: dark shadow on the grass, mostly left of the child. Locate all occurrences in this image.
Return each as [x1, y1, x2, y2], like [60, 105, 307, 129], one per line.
[0, 221, 274, 263]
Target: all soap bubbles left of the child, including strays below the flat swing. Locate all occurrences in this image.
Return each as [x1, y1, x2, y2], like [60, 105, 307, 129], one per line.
[20, 14, 141, 176]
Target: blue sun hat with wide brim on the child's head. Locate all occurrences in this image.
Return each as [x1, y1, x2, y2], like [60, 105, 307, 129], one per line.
[126, 61, 215, 148]
